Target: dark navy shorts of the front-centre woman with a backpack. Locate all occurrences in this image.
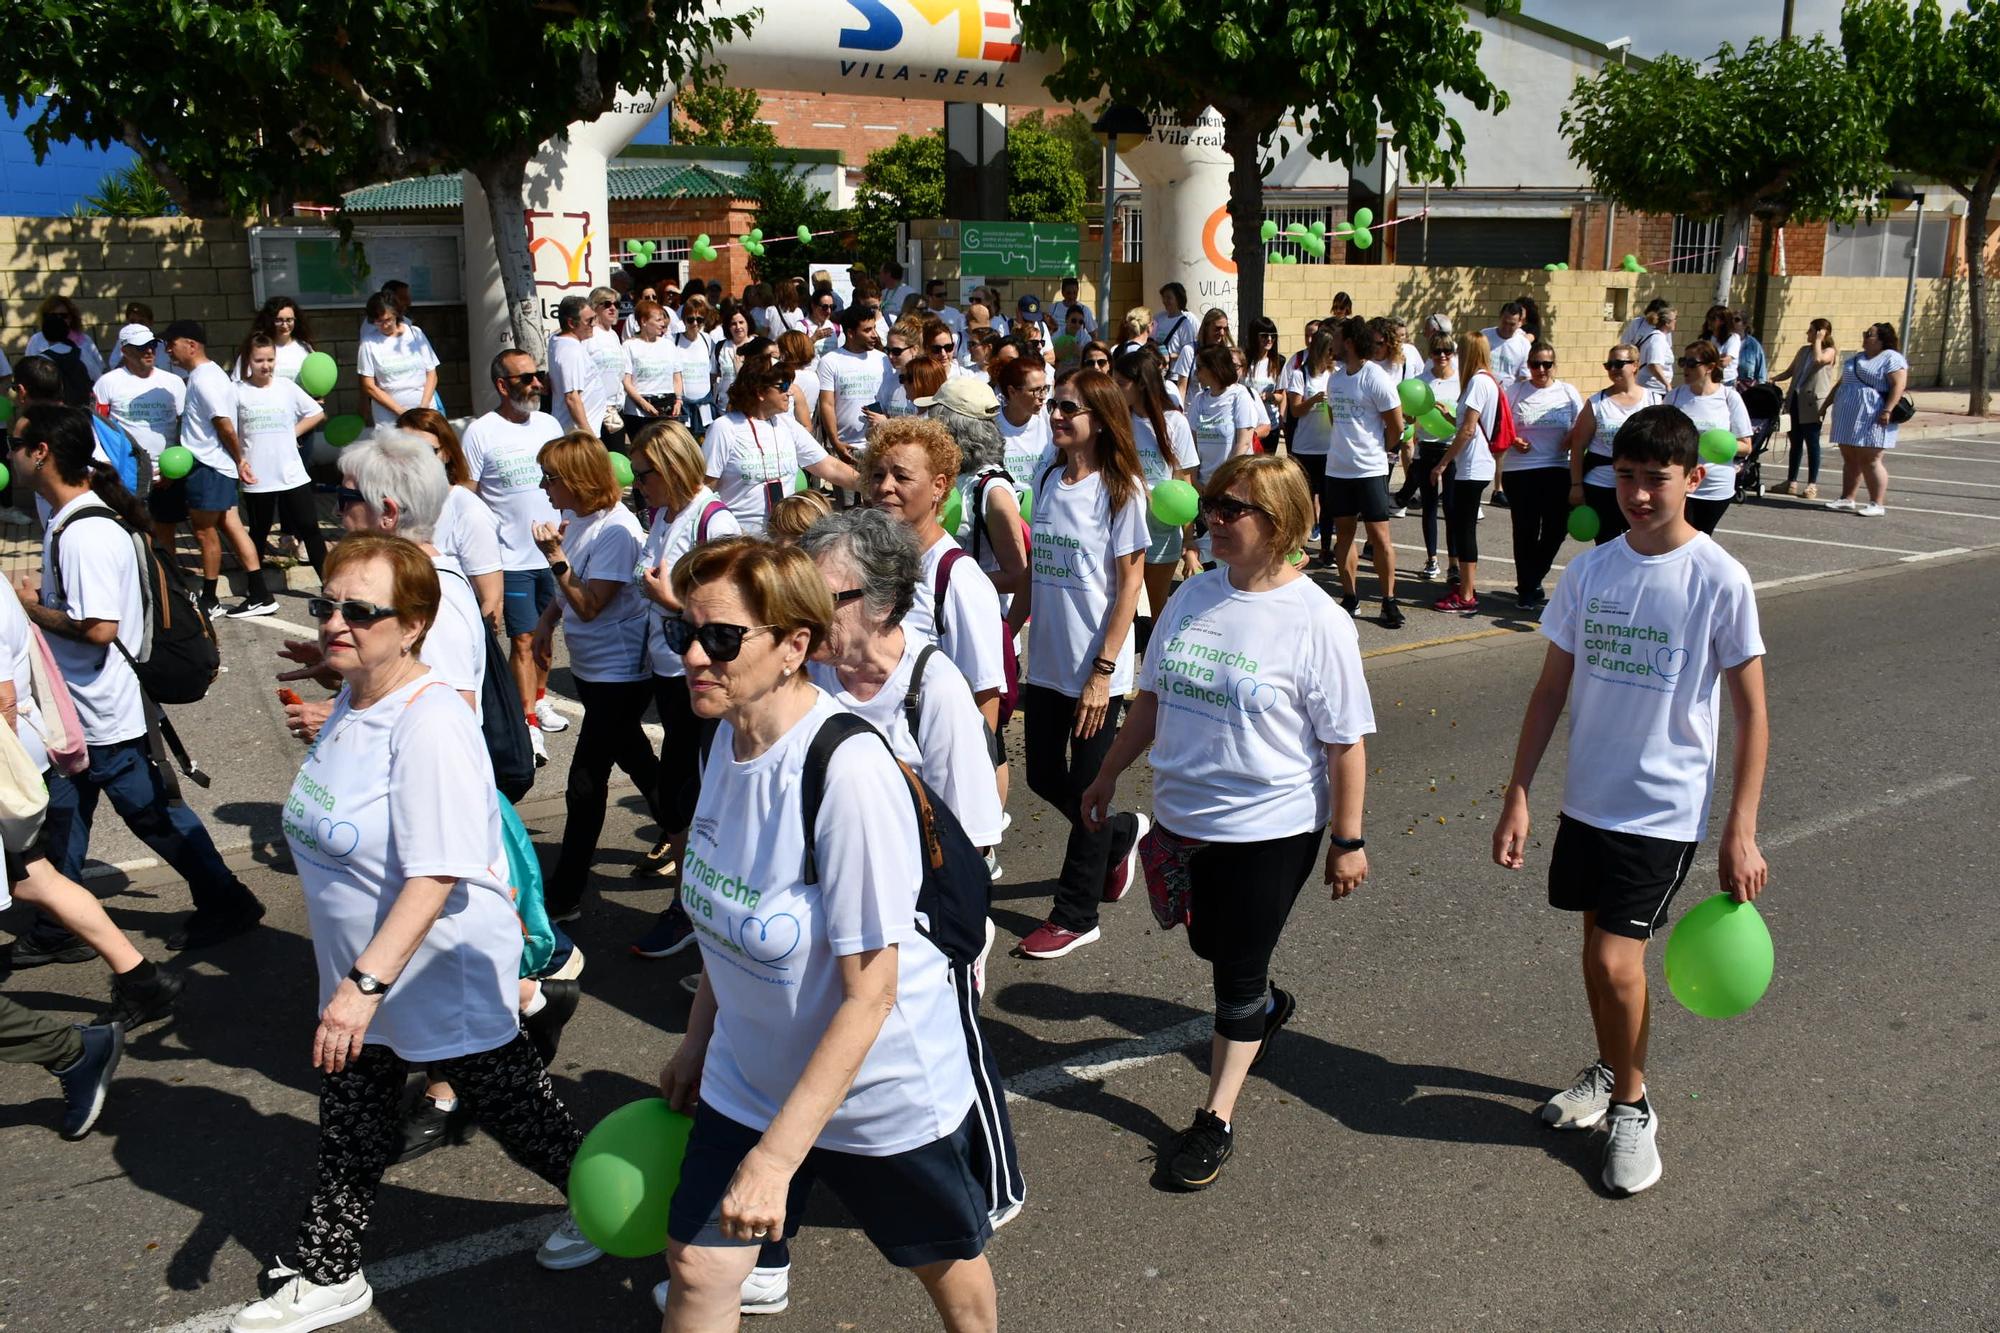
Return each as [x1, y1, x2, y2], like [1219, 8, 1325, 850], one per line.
[666, 1107, 994, 1269]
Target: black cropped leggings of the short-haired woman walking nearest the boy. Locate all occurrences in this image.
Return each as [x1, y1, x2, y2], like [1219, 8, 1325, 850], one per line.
[1188, 829, 1326, 1041]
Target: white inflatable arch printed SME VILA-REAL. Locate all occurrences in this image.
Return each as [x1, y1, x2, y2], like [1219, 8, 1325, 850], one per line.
[464, 0, 1236, 410]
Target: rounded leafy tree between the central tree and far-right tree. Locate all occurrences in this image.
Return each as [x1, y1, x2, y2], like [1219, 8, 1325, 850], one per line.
[1562, 38, 1888, 304]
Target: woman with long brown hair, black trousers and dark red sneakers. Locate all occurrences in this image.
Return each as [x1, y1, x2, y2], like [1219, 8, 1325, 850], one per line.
[1008, 370, 1148, 959]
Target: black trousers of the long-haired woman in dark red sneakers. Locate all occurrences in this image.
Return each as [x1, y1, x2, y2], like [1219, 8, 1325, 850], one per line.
[1022, 685, 1138, 935]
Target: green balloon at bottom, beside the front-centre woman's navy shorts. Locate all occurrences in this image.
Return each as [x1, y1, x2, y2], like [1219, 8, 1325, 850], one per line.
[568, 1097, 694, 1259]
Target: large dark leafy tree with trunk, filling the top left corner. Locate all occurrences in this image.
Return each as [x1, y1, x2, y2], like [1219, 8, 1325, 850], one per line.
[0, 0, 750, 354]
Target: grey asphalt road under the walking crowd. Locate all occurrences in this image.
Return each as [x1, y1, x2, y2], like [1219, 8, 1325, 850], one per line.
[0, 454, 2000, 1333]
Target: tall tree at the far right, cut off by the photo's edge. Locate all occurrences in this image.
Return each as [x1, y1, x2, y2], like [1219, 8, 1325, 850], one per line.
[1840, 0, 2000, 414]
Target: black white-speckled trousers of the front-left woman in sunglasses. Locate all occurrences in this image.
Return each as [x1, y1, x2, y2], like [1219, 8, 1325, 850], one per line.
[292, 1033, 584, 1287]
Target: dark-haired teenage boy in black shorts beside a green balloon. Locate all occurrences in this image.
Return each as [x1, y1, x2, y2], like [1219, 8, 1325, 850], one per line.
[1494, 406, 1770, 1195]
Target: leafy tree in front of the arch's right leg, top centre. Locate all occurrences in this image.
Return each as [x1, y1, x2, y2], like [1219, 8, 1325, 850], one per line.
[1020, 0, 1518, 328]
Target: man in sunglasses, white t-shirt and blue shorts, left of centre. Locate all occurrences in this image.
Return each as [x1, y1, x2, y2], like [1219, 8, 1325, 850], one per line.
[462, 348, 564, 763]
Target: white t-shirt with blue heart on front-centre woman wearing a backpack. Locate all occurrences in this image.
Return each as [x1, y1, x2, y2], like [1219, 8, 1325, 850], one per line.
[680, 693, 972, 1157]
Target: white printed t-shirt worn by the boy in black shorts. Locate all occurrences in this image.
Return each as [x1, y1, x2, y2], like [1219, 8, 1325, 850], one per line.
[1542, 534, 1764, 843]
